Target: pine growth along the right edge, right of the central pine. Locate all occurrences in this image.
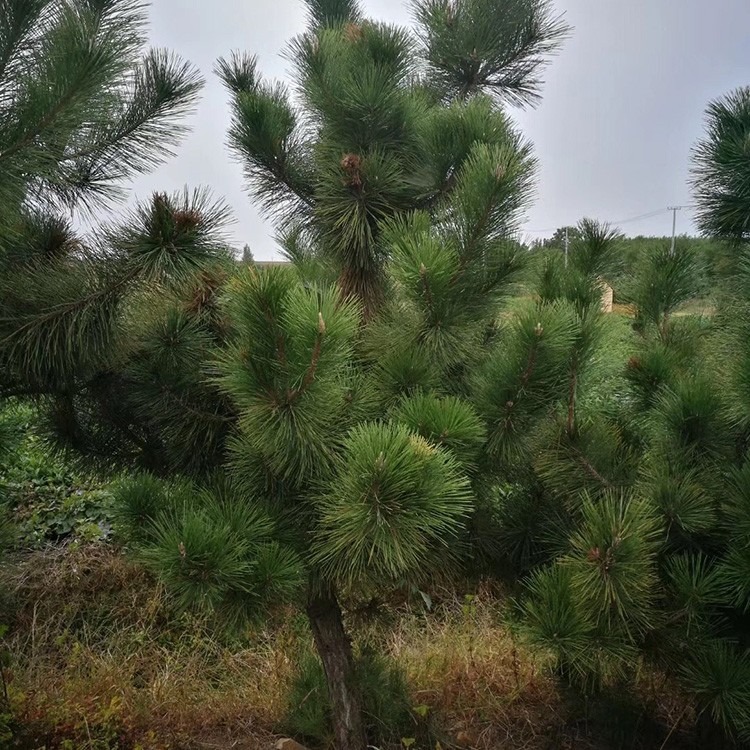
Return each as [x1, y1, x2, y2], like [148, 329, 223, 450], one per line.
[520, 91, 750, 746]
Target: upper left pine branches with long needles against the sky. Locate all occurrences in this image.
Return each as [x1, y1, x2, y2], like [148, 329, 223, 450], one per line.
[0, 0, 201, 217]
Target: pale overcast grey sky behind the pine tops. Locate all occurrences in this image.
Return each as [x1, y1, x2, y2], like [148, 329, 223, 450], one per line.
[128, 0, 750, 259]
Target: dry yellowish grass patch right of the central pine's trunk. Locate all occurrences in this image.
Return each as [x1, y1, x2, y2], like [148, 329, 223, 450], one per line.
[388, 589, 566, 750]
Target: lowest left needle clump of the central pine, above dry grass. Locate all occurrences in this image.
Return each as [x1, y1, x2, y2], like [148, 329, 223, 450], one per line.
[114, 474, 303, 627]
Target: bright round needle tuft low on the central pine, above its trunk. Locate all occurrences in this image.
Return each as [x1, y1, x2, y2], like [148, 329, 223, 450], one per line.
[313, 424, 471, 586]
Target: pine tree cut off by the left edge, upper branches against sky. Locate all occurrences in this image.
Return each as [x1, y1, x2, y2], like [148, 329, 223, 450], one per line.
[0, 0, 202, 406]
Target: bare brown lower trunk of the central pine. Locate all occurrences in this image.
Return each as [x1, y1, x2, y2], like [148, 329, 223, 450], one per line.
[307, 590, 367, 750]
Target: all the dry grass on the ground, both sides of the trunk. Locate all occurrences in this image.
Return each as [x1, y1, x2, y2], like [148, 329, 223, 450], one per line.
[0, 544, 704, 750]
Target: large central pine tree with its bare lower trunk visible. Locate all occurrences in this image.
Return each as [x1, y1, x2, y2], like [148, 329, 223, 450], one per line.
[0, 0, 577, 750]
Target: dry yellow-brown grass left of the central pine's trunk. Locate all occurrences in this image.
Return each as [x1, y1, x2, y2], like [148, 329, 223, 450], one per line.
[5, 547, 299, 750]
